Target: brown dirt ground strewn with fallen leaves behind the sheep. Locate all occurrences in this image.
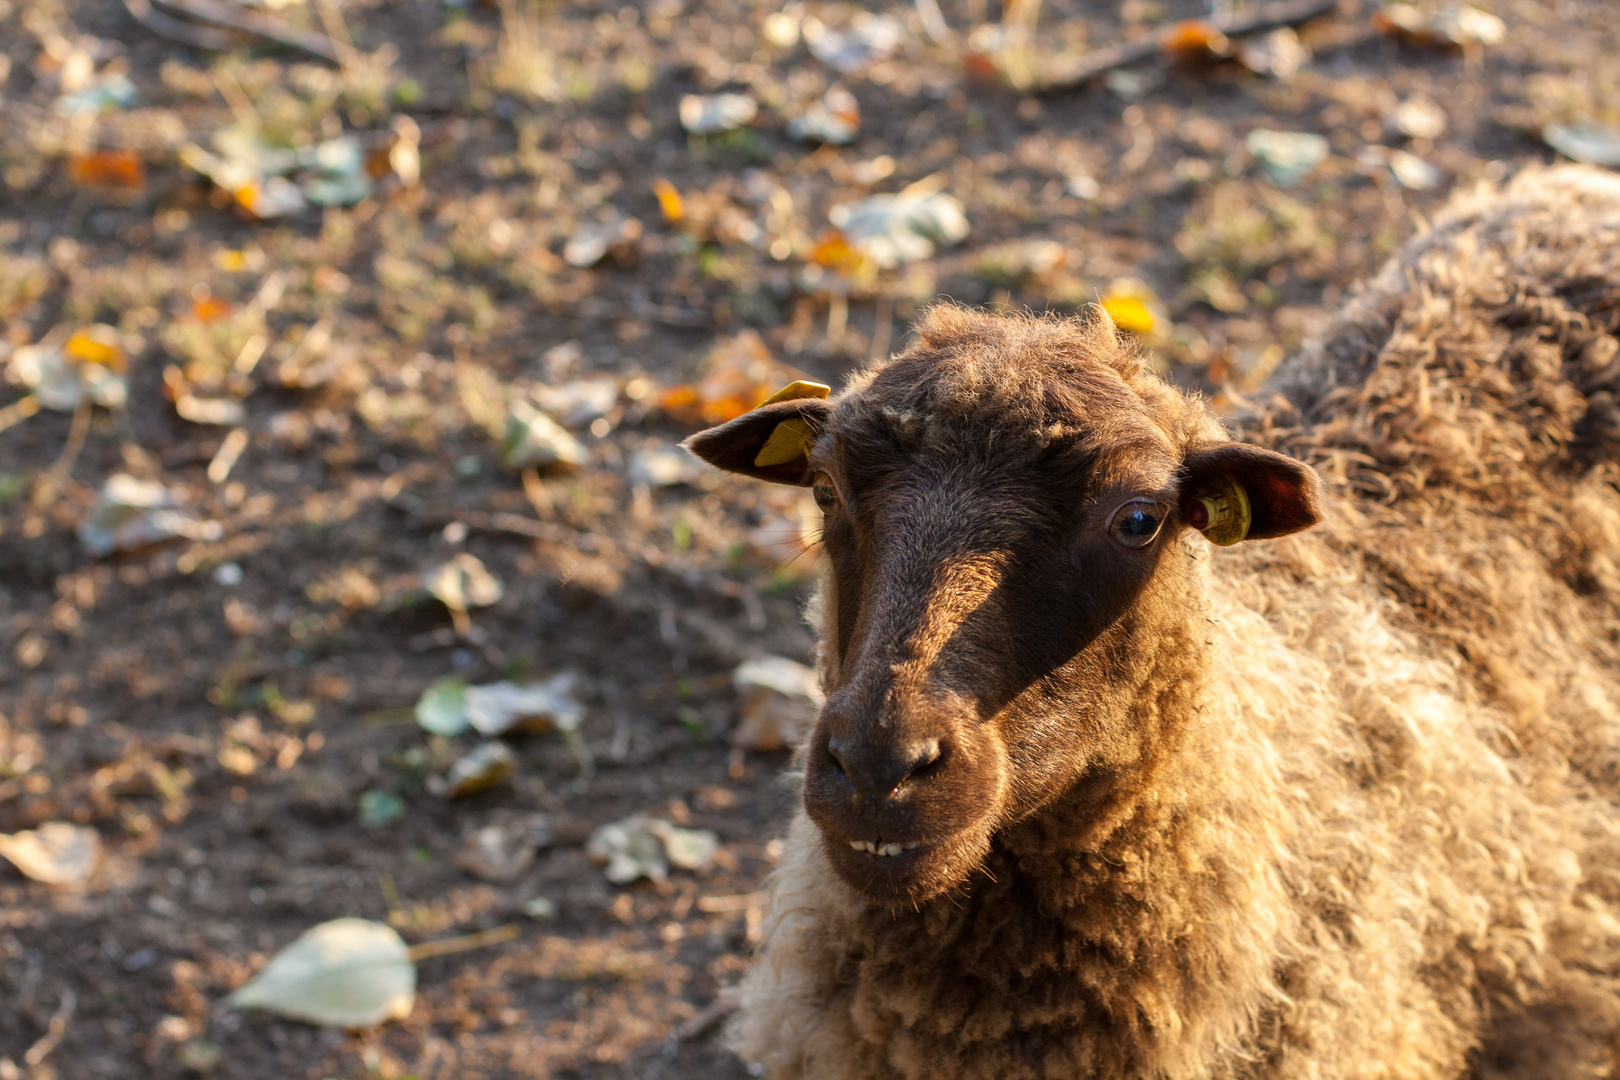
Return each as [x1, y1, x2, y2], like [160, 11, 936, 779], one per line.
[0, 0, 1620, 1080]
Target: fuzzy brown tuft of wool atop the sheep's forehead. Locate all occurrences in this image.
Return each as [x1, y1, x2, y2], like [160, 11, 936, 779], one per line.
[846, 304, 1226, 450]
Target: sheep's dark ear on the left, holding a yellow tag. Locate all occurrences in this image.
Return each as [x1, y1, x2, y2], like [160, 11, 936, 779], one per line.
[680, 382, 833, 487]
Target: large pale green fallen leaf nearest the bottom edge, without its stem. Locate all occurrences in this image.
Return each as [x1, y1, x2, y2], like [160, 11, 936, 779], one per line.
[225, 918, 416, 1028]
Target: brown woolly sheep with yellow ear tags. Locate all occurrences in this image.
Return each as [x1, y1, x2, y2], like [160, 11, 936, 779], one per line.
[689, 167, 1620, 1080]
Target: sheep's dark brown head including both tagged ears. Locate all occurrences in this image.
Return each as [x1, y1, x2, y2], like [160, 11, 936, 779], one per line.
[687, 308, 1320, 905]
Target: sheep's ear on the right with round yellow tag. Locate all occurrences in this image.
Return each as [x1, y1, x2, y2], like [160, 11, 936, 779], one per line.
[1181, 442, 1322, 546]
